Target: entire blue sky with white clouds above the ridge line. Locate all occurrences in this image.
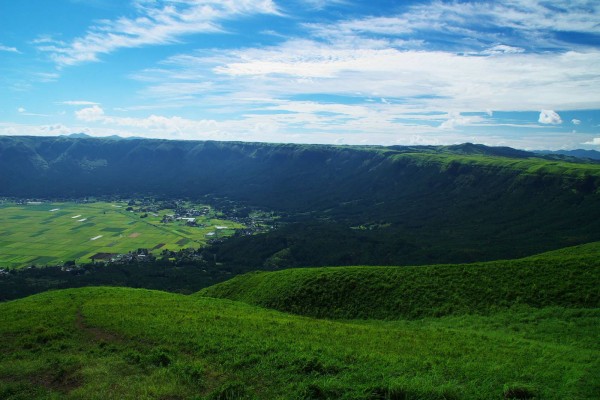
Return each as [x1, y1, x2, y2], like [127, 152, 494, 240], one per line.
[0, 0, 600, 150]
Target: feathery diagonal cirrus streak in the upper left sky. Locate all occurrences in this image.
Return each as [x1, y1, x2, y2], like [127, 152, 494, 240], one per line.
[36, 0, 278, 66]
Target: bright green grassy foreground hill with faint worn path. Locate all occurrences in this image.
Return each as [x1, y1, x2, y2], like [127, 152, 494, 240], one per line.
[0, 288, 600, 400]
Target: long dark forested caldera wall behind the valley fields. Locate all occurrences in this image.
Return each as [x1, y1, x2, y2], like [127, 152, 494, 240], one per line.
[0, 137, 600, 267]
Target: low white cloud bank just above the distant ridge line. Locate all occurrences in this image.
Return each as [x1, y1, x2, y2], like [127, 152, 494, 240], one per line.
[70, 101, 450, 144]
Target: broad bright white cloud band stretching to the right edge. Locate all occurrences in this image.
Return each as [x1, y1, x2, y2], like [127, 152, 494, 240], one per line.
[203, 40, 600, 111]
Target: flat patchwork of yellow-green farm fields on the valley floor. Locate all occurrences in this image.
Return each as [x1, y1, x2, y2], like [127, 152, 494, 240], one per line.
[0, 202, 243, 268]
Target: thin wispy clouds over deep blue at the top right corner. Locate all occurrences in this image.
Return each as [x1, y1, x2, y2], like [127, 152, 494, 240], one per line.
[306, 0, 600, 50]
